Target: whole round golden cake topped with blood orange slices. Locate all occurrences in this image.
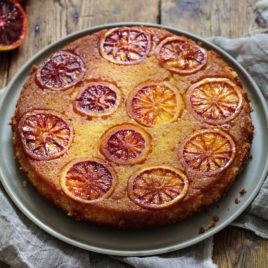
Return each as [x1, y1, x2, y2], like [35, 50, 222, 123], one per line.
[11, 27, 254, 229]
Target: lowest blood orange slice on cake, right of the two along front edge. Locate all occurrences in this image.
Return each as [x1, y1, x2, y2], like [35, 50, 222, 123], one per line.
[128, 166, 189, 209]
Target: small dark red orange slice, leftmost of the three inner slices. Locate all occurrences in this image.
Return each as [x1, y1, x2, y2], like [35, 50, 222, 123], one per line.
[74, 82, 121, 117]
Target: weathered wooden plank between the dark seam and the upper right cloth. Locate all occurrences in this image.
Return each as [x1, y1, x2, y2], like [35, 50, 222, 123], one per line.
[161, 0, 256, 37]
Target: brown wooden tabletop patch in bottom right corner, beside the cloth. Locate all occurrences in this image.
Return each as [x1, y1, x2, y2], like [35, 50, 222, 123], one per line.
[213, 227, 268, 268]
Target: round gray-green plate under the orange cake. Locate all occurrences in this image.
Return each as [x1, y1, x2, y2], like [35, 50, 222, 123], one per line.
[0, 23, 268, 256]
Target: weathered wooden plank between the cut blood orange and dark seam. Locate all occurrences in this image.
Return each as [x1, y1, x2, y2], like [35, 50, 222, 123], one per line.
[9, 0, 158, 78]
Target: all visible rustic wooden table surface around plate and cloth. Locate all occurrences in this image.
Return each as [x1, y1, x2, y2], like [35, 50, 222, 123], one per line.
[0, 0, 268, 268]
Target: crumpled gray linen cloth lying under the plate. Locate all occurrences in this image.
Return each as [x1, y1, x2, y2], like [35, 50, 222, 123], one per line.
[0, 1, 268, 268]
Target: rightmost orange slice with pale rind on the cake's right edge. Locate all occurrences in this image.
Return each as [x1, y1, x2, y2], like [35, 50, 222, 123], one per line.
[186, 78, 243, 125]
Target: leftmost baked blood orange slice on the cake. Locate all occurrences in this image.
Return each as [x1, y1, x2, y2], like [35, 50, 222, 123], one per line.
[18, 110, 73, 160]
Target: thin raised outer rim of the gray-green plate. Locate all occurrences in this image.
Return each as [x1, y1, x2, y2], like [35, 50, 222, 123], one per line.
[0, 22, 268, 256]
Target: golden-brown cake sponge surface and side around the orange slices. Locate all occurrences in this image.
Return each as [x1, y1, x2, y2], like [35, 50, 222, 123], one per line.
[12, 27, 253, 229]
